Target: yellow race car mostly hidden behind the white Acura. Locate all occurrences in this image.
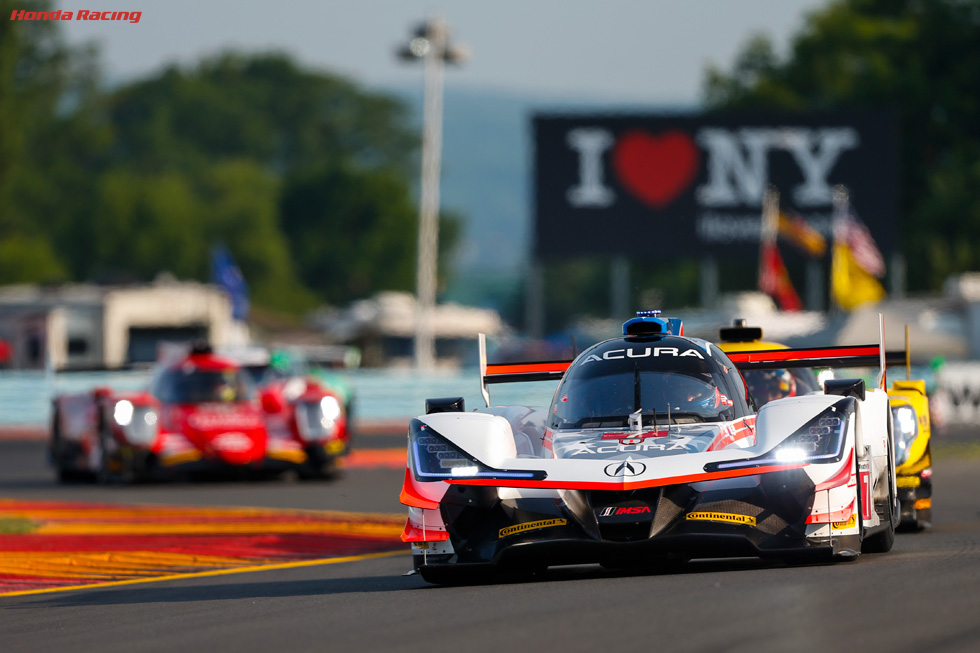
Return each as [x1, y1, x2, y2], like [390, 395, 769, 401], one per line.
[718, 319, 932, 531]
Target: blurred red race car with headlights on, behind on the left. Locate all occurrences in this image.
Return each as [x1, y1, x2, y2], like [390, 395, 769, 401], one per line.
[50, 344, 350, 482]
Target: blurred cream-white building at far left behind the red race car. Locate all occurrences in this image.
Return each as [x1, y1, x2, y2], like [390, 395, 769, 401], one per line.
[0, 280, 242, 370]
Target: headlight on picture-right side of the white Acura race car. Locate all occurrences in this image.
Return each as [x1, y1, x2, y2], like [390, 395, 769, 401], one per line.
[704, 397, 856, 472]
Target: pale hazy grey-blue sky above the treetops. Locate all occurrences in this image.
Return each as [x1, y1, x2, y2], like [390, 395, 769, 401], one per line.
[57, 0, 826, 103]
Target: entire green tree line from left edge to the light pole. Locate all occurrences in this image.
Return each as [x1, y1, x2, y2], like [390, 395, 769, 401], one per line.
[0, 0, 459, 313]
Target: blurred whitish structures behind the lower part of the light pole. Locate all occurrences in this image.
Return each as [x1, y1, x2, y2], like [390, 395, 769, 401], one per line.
[314, 292, 504, 368]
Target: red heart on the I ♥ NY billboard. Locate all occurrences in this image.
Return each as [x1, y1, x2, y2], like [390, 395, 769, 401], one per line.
[613, 130, 701, 209]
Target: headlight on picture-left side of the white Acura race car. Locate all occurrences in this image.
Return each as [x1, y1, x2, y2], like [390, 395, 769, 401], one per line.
[408, 419, 547, 481]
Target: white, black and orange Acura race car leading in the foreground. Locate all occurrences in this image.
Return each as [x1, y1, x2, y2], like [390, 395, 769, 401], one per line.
[400, 311, 899, 583]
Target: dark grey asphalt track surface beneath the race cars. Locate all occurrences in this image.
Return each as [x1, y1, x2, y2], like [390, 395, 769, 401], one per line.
[0, 430, 980, 653]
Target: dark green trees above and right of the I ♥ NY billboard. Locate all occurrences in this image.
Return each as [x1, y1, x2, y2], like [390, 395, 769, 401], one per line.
[704, 0, 980, 289]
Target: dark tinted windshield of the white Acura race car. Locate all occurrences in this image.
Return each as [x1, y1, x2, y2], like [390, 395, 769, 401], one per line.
[549, 349, 736, 429]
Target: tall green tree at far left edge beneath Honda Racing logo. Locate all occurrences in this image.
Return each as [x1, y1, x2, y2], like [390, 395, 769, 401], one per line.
[0, 0, 108, 283]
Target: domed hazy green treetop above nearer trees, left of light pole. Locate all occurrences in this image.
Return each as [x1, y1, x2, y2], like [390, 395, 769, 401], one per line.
[110, 52, 418, 174]
